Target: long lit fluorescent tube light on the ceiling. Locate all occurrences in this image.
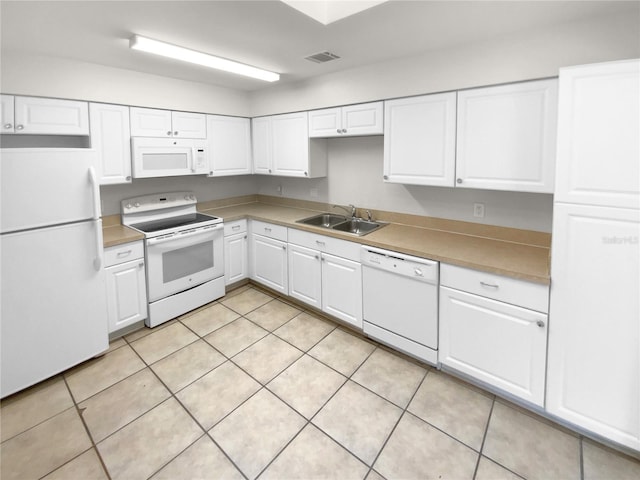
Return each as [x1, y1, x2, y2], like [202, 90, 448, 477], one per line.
[129, 35, 280, 82]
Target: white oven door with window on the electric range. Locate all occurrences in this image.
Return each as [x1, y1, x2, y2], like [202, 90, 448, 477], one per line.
[147, 223, 224, 302]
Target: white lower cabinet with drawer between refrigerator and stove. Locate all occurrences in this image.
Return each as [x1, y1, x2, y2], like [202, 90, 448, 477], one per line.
[104, 241, 147, 333]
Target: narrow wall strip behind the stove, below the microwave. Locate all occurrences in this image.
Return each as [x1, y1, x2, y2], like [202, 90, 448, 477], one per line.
[100, 175, 258, 216]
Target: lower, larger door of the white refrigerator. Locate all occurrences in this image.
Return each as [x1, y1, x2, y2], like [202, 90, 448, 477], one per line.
[0, 220, 108, 397]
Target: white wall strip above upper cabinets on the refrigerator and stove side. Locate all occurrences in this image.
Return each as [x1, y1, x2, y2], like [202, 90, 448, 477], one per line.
[0, 53, 250, 116]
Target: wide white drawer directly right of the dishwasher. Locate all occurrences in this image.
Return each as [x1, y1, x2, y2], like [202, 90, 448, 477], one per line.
[440, 263, 549, 313]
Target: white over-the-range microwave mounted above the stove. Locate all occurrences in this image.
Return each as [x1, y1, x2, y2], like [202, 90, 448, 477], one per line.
[131, 137, 209, 178]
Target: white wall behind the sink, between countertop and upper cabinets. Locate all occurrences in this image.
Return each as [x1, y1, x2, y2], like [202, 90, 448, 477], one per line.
[258, 136, 553, 232]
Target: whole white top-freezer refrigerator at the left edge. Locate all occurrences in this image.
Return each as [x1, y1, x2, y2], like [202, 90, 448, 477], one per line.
[0, 149, 108, 397]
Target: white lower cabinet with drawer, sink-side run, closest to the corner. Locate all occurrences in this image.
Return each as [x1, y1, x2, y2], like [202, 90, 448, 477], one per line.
[250, 220, 289, 295]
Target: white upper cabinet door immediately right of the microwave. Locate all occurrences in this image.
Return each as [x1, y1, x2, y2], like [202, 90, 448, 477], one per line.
[207, 115, 251, 177]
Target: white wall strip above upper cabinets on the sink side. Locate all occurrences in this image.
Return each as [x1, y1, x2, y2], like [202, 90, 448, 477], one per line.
[250, 11, 640, 116]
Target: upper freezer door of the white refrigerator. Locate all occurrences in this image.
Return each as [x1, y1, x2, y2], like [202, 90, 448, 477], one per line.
[0, 148, 100, 233]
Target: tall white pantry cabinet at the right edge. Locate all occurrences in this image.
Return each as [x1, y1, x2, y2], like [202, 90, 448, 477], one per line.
[546, 60, 640, 450]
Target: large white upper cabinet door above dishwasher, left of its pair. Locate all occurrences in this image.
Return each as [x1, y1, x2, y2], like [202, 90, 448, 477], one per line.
[384, 93, 456, 187]
